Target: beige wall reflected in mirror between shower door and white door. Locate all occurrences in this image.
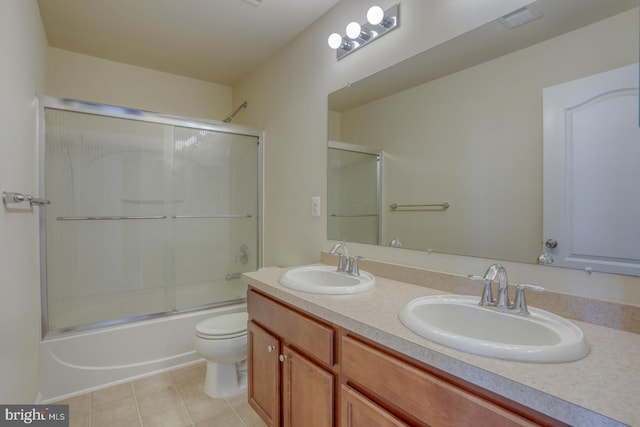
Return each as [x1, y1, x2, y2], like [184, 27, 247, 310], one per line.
[338, 10, 638, 263]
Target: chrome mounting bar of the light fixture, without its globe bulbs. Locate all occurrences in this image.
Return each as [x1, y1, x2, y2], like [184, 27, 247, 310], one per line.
[329, 3, 400, 60]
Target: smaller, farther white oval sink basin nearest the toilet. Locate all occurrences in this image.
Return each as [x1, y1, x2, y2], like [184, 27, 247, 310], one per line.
[279, 265, 376, 294]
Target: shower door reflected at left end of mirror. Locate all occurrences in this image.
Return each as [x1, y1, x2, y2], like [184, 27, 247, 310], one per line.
[327, 141, 382, 244]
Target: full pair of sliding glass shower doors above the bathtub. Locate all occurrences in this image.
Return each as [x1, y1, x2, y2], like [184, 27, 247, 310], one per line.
[42, 103, 260, 331]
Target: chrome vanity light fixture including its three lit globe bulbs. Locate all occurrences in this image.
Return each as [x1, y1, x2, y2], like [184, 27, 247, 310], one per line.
[327, 4, 400, 60]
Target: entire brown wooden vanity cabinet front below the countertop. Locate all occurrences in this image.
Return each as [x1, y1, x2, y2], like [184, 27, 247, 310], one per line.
[247, 288, 567, 427]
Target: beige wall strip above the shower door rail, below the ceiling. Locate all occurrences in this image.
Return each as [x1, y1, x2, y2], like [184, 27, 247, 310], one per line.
[46, 47, 232, 120]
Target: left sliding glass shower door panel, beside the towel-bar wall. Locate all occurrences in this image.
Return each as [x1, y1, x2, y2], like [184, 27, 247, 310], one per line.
[45, 109, 173, 330]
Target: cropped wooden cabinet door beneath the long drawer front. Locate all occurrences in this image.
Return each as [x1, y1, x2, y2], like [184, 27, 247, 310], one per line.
[340, 385, 409, 427]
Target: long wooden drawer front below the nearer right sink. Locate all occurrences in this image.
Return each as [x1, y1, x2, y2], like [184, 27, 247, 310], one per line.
[341, 336, 539, 427]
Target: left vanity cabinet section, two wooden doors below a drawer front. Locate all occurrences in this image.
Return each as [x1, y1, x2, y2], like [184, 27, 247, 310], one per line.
[247, 290, 338, 427]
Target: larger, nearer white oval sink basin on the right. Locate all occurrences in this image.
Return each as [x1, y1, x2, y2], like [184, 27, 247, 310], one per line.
[399, 295, 589, 363]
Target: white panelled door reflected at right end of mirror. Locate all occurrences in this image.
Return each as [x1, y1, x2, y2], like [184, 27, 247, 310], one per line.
[543, 64, 640, 275]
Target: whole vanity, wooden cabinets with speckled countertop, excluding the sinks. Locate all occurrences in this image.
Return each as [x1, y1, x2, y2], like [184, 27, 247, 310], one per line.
[243, 269, 640, 426]
